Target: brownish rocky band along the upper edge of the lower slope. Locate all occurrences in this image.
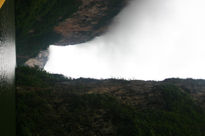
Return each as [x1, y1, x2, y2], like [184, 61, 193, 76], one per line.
[56, 78, 205, 109]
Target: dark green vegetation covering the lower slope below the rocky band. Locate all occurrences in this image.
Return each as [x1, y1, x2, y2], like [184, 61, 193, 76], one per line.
[16, 67, 205, 136]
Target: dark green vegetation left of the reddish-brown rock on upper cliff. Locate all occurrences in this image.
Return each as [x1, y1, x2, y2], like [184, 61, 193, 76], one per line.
[15, 0, 80, 63]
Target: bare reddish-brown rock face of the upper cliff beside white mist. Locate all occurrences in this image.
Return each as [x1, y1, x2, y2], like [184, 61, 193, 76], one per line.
[54, 0, 126, 45]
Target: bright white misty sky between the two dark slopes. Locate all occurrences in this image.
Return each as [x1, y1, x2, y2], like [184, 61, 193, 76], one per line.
[45, 0, 205, 80]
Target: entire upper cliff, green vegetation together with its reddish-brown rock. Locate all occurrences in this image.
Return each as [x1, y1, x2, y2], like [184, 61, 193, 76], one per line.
[16, 0, 127, 65]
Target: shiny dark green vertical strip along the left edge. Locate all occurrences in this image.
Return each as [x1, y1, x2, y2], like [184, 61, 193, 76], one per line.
[0, 0, 16, 136]
